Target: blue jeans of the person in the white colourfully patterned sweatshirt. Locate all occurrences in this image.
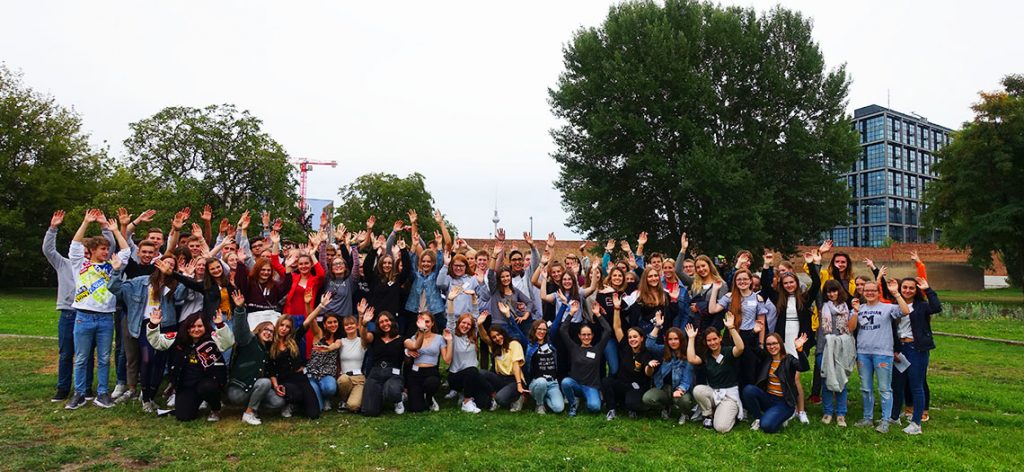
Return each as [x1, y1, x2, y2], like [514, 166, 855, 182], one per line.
[75, 310, 114, 395]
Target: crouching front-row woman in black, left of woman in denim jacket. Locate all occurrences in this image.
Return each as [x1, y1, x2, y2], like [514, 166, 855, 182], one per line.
[601, 290, 662, 421]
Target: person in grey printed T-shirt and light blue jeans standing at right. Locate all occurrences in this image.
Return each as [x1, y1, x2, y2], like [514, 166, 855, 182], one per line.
[849, 281, 910, 433]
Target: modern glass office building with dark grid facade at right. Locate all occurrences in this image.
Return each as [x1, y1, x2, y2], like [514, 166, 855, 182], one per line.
[829, 104, 951, 248]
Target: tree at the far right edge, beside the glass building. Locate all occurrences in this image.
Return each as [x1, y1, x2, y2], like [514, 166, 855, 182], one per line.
[924, 75, 1024, 287]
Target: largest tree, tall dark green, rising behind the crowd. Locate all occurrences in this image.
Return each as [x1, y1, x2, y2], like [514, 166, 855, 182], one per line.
[549, 0, 858, 258]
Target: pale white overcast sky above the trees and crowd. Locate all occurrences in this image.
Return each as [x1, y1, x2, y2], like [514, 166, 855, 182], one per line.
[0, 0, 1024, 239]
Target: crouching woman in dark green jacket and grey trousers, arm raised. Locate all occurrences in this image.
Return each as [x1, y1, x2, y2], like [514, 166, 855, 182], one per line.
[227, 290, 285, 426]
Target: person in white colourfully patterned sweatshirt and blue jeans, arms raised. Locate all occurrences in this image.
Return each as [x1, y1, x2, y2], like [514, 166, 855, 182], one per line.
[65, 209, 131, 410]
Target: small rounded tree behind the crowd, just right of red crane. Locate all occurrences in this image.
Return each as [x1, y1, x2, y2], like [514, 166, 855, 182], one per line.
[334, 172, 456, 243]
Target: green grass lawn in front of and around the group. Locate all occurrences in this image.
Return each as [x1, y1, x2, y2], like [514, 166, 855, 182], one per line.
[0, 290, 1024, 470]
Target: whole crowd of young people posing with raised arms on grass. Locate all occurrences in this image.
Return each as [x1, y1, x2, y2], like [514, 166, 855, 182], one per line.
[43, 203, 941, 434]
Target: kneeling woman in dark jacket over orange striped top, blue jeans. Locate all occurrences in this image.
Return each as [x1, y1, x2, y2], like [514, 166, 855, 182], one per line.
[742, 325, 811, 433]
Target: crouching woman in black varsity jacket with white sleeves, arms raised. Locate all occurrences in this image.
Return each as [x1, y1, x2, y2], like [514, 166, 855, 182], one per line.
[145, 308, 234, 421]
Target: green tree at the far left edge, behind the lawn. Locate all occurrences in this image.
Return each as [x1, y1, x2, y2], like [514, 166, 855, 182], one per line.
[0, 65, 105, 286]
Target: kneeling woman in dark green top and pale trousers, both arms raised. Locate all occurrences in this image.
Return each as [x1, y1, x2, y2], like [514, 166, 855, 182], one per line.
[686, 311, 743, 433]
